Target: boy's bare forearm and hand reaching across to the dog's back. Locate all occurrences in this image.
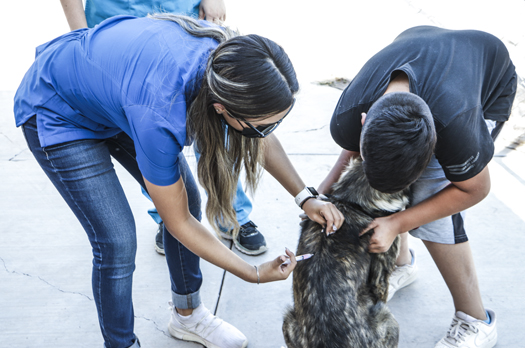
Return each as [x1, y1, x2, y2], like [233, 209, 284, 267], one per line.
[361, 167, 490, 253]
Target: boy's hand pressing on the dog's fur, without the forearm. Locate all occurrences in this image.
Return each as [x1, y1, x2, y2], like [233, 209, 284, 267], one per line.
[359, 214, 406, 253]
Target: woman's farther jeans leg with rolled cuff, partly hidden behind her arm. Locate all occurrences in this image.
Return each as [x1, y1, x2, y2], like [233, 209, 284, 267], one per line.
[107, 133, 202, 309]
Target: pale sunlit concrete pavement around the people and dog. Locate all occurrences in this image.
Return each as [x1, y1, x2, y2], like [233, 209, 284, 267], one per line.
[0, 0, 525, 348]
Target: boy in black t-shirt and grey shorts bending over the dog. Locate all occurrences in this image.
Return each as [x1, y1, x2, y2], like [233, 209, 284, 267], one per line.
[319, 26, 517, 348]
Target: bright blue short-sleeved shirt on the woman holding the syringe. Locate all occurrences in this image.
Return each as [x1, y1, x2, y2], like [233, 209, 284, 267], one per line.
[14, 16, 217, 186]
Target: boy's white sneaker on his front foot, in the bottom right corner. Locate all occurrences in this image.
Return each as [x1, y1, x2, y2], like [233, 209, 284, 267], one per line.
[435, 309, 498, 348]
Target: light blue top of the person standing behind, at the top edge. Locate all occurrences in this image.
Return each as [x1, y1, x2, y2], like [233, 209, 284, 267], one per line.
[85, 0, 201, 28]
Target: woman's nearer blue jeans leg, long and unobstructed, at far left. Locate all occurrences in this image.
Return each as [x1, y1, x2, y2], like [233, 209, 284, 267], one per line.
[23, 118, 137, 348]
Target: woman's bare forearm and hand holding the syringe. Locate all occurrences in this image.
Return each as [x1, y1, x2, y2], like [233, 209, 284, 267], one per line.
[144, 178, 296, 283]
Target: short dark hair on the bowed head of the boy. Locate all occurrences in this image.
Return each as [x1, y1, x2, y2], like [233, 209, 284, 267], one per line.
[361, 92, 436, 193]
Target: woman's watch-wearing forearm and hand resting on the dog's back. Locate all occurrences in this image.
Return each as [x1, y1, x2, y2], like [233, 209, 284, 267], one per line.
[264, 134, 344, 234]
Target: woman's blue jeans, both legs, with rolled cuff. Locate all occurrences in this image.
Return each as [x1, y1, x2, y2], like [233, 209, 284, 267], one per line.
[22, 117, 202, 348]
